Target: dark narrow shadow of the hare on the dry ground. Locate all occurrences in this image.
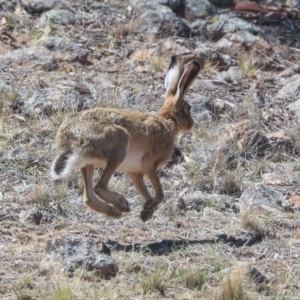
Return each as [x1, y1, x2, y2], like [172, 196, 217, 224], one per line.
[105, 233, 264, 256]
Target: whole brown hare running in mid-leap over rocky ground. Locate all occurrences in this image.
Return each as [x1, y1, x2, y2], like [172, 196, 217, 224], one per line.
[51, 56, 202, 222]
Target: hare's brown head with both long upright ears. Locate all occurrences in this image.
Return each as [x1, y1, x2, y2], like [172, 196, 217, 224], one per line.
[158, 56, 201, 131]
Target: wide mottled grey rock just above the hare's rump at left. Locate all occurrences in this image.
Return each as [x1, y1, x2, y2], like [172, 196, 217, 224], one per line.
[24, 88, 87, 115]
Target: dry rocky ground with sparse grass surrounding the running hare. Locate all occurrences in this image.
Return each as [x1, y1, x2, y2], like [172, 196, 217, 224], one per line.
[0, 0, 300, 300]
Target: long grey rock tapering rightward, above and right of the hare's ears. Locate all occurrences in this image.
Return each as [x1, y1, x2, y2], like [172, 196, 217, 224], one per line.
[205, 14, 262, 41]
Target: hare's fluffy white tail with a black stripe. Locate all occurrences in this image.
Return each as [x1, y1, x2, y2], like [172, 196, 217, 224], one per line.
[50, 149, 79, 180]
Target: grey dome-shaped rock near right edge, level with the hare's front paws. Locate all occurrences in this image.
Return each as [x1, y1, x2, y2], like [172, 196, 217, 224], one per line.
[239, 184, 285, 215]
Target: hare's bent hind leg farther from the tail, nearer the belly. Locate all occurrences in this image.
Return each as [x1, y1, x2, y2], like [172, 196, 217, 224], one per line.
[94, 158, 130, 212]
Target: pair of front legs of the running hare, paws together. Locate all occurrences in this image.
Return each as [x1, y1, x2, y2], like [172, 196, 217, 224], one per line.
[128, 169, 164, 222]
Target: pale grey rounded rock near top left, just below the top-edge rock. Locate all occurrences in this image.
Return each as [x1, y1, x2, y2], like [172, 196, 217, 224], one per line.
[40, 9, 76, 26]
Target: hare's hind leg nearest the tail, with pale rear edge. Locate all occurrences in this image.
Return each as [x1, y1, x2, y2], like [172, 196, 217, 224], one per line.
[81, 165, 121, 218]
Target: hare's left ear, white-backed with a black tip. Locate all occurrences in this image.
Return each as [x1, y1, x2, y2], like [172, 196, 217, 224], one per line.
[165, 55, 184, 96]
